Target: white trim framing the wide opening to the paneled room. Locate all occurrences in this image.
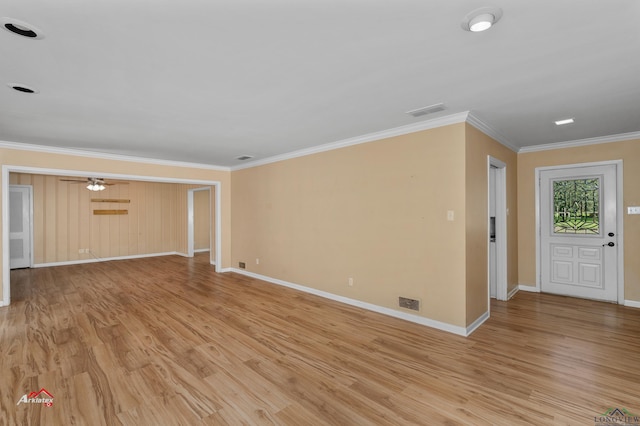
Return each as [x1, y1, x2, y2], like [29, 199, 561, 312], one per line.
[1, 164, 222, 306]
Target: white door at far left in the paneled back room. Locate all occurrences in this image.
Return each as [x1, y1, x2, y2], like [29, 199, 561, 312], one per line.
[9, 185, 31, 269]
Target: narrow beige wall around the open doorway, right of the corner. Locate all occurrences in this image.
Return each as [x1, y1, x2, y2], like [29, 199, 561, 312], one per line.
[466, 124, 518, 325]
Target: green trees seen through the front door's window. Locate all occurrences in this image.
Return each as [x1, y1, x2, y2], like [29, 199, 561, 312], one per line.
[553, 178, 600, 234]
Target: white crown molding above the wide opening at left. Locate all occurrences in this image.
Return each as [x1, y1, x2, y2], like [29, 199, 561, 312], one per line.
[0, 141, 231, 172]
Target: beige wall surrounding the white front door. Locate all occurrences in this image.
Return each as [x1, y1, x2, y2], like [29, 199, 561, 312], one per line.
[518, 140, 640, 301]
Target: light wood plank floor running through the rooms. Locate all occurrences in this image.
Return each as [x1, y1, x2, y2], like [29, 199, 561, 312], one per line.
[0, 256, 640, 426]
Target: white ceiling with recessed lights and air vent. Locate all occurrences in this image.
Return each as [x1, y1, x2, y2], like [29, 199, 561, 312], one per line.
[0, 0, 640, 167]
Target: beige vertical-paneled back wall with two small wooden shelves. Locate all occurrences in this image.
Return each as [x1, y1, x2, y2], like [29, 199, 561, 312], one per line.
[10, 173, 213, 264]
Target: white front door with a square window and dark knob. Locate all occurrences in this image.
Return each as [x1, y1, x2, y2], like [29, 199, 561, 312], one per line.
[540, 164, 618, 302]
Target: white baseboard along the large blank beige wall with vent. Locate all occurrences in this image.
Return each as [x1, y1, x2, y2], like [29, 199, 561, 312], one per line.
[229, 268, 476, 337]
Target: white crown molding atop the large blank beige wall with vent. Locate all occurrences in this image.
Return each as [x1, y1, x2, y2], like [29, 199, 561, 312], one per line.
[231, 111, 469, 171]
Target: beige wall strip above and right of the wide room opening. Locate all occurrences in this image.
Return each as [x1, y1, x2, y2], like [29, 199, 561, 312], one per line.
[0, 148, 231, 302]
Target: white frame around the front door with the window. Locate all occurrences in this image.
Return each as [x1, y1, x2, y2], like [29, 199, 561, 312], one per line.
[535, 160, 624, 305]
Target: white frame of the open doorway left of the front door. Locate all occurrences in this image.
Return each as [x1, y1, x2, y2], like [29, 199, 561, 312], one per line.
[487, 155, 509, 307]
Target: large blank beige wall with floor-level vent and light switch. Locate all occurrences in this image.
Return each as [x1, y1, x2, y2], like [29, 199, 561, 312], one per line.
[232, 124, 467, 326]
